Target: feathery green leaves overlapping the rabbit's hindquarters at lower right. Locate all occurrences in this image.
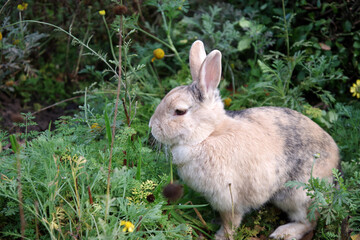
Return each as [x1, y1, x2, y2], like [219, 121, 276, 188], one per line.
[286, 161, 360, 239]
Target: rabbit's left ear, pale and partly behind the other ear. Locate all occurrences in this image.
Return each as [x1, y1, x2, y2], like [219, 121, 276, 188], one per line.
[189, 40, 206, 81]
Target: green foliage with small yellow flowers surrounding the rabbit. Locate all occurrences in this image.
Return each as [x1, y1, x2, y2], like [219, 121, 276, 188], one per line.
[0, 0, 360, 239]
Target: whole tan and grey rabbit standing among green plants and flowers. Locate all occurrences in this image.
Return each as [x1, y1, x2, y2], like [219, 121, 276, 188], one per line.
[149, 40, 340, 240]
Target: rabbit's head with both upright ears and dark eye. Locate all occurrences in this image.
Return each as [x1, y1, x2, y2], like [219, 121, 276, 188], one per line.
[149, 41, 225, 146]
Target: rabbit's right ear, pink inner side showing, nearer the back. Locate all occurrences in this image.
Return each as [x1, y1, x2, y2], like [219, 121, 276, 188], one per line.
[199, 50, 221, 95]
